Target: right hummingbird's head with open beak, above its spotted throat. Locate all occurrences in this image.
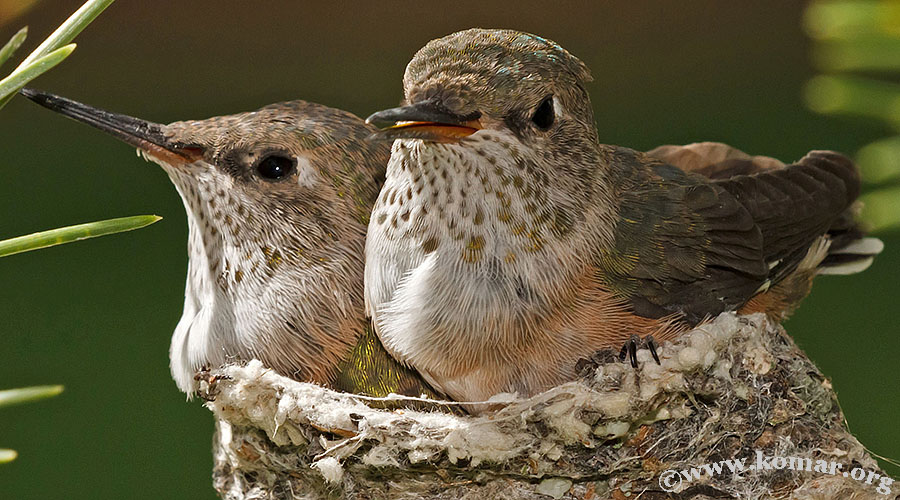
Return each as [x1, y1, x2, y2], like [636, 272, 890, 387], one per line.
[367, 29, 596, 147]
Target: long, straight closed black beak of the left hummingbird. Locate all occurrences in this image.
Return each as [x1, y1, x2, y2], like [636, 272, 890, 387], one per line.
[19, 88, 203, 164]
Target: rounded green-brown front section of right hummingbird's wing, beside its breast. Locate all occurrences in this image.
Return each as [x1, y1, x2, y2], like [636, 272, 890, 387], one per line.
[599, 149, 768, 323]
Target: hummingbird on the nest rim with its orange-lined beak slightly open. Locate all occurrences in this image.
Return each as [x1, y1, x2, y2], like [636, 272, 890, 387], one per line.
[365, 29, 881, 402]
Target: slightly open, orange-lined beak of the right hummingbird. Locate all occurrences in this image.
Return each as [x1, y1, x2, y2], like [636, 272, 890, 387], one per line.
[366, 99, 482, 142]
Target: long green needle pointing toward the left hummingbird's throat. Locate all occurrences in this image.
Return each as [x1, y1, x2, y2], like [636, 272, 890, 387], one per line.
[0, 215, 162, 257]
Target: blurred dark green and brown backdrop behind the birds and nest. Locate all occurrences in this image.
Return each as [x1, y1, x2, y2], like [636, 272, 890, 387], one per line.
[0, 0, 900, 499]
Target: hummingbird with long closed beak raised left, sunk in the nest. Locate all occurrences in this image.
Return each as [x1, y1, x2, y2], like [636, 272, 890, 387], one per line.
[22, 89, 434, 397]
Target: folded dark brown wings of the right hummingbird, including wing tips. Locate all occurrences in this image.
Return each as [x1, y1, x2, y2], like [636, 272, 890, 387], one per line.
[603, 143, 859, 323]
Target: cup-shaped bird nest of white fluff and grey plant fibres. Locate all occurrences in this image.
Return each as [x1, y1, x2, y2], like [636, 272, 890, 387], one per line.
[205, 313, 900, 499]
